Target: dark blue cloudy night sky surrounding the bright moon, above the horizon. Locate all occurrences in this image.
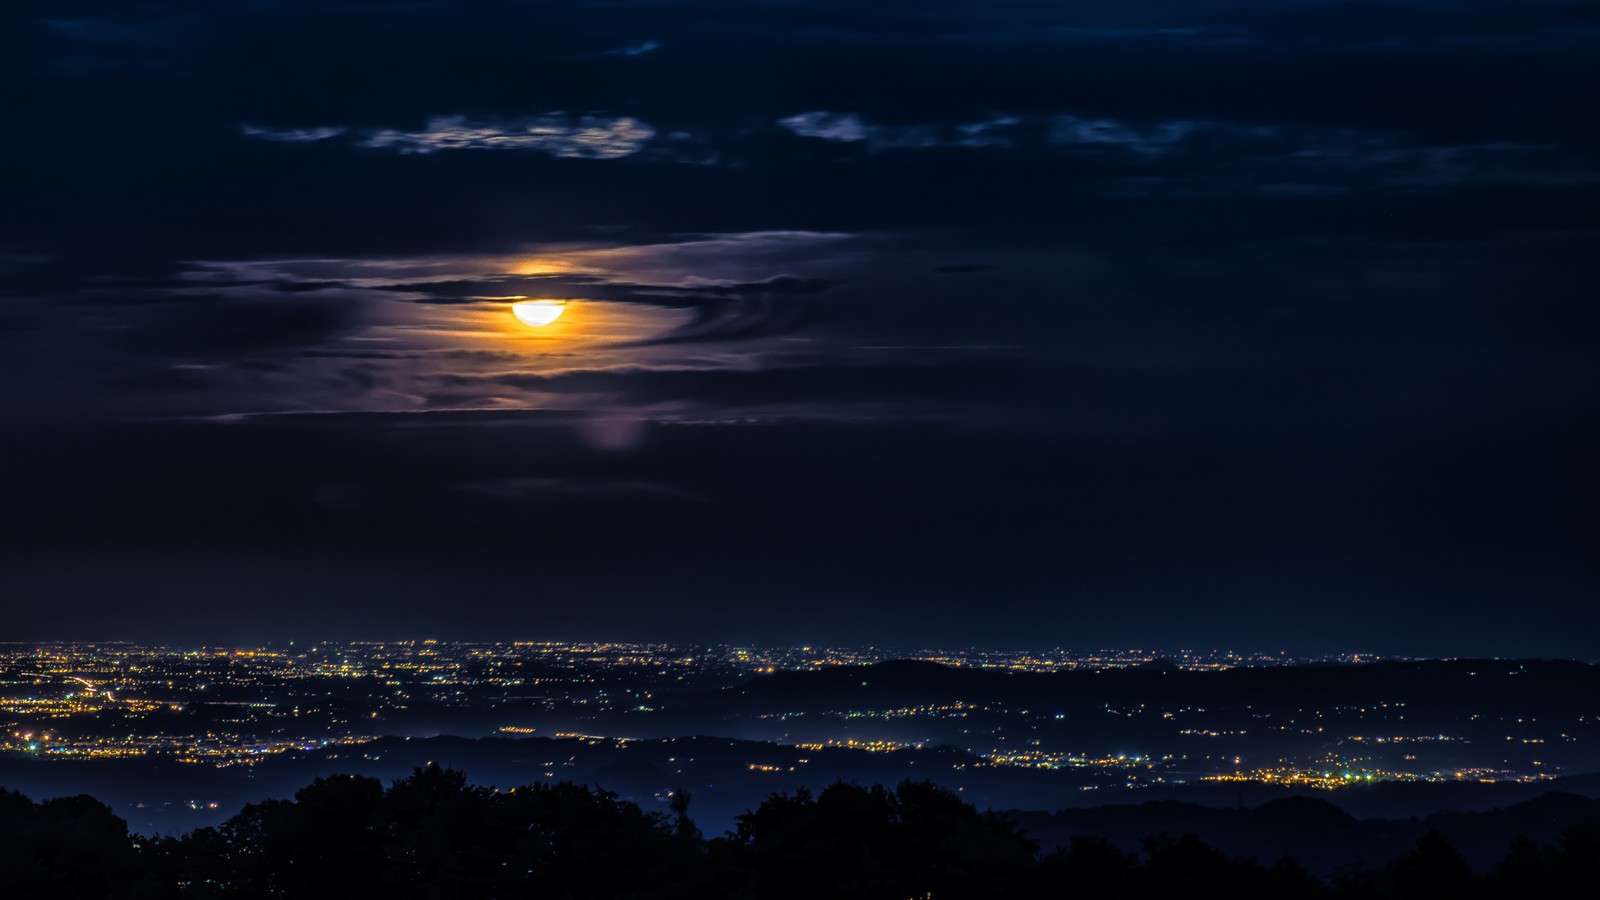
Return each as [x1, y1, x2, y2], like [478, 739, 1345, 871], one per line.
[0, 0, 1600, 658]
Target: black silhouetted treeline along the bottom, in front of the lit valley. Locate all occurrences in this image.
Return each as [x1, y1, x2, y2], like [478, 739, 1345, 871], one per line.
[0, 765, 1600, 900]
